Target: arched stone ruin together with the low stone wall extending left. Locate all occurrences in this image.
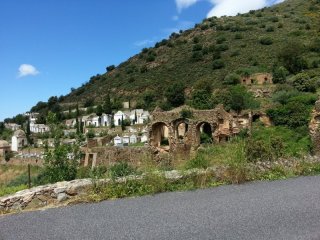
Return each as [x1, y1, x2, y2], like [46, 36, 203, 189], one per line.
[82, 105, 255, 167]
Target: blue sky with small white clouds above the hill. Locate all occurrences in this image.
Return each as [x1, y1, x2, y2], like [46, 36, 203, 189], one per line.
[0, 0, 277, 121]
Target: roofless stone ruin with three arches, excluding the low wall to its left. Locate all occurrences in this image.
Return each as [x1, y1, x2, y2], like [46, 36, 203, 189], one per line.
[149, 105, 252, 158]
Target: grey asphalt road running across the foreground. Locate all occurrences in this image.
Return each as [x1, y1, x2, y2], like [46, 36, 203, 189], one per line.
[0, 177, 320, 240]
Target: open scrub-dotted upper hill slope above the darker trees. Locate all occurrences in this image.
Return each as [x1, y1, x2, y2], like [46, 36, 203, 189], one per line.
[51, 0, 320, 108]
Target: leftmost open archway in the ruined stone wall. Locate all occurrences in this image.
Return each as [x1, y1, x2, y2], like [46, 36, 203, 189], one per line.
[150, 122, 170, 148]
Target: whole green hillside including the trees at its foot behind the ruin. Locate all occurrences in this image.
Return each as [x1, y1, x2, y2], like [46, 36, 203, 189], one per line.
[4, 0, 320, 131]
